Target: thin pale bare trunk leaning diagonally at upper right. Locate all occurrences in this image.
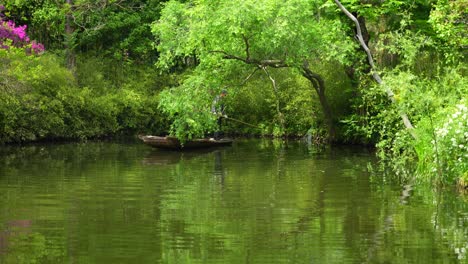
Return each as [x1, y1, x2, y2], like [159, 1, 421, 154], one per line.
[334, 0, 416, 138]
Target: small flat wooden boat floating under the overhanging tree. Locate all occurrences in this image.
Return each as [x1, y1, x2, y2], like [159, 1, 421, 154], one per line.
[139, 136, 233, 150]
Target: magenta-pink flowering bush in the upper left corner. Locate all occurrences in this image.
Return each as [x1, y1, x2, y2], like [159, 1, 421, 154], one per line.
[0, 5, 44, 54]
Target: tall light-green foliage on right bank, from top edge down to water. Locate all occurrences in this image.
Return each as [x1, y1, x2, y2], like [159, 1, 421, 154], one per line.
[336, 1, 468, 186]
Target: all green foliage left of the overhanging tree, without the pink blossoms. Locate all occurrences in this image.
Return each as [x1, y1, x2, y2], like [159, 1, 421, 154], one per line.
[0, 0, 171, 142]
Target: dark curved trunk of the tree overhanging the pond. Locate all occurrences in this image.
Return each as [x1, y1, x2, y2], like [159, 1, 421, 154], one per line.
[302, 62, 336, 142]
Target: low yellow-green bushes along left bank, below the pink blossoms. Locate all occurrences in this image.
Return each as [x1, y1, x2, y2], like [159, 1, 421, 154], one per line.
[0, 46, 168, 142]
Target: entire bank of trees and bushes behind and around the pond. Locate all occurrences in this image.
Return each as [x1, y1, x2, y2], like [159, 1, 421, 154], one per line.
[0, 0, 468, 188]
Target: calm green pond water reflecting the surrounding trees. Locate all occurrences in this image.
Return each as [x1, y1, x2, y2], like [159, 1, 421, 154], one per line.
[0, 140, 468, 264]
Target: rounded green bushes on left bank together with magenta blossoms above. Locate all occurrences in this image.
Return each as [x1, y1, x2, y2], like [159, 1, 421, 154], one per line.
[0, 2, 168, 142]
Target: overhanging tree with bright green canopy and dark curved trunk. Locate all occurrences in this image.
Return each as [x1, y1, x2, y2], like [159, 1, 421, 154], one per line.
[153, 0, 353, 140]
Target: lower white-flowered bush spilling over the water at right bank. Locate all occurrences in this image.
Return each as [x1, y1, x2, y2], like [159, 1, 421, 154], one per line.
[346, 66, 468, 183]
